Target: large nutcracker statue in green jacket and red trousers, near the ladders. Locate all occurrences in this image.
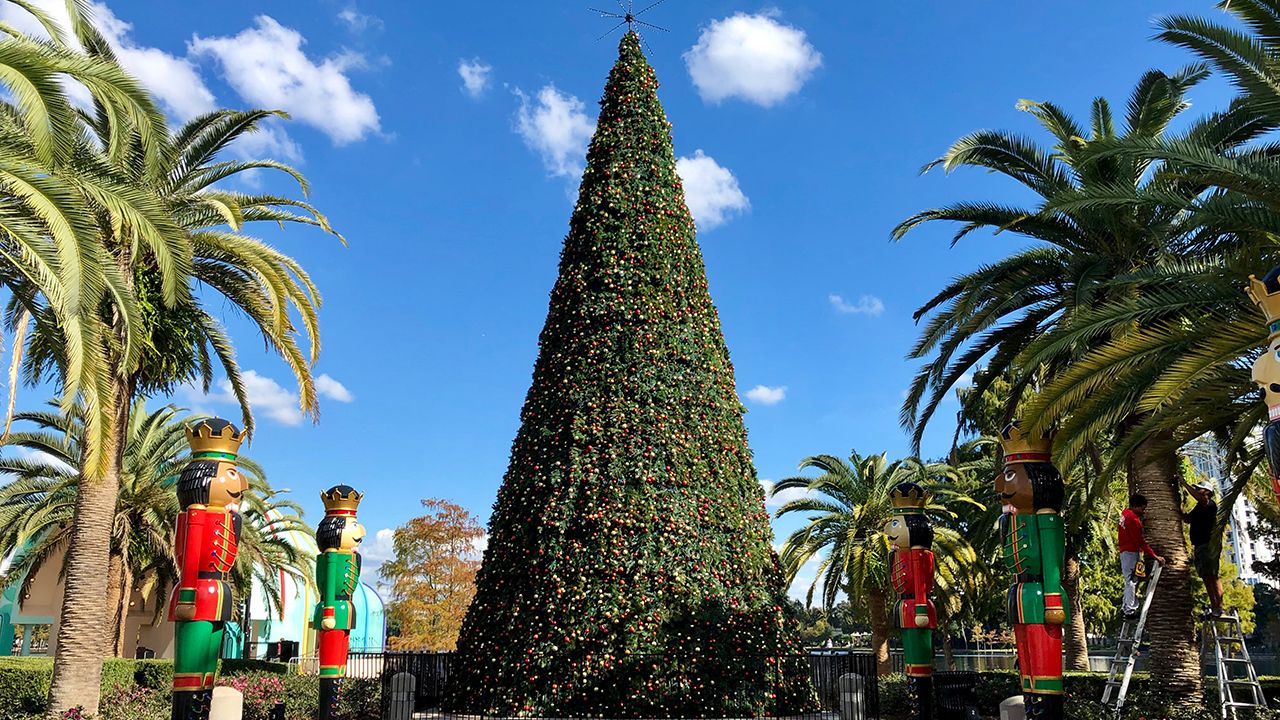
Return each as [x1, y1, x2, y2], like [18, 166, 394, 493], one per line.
[996, 420, 1068, 720]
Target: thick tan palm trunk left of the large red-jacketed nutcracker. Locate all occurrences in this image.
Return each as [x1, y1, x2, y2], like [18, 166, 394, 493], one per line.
[49, 378, 133, 716]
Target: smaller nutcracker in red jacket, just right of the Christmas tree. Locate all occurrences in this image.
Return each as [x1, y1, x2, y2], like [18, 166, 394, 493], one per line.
[884, 483, 938, 720]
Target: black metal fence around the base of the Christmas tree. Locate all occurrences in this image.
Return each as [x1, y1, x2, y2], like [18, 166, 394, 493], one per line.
[373, 651, 881, 720]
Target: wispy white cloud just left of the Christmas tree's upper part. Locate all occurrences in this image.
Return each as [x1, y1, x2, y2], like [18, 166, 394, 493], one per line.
[516, 85, 595, 177]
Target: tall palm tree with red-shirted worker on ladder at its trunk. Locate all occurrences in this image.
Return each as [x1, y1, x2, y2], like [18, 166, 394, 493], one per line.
[893, 67, 1274, 697]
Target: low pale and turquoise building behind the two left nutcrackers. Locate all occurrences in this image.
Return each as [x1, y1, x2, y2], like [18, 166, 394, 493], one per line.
[0, 512, 387, 659]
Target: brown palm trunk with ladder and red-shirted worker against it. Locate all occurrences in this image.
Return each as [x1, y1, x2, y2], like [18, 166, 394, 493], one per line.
[1129, 433, 1201, 701]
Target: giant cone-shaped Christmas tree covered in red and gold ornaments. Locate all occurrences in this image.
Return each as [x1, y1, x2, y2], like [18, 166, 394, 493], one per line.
[449, 32, 812, 717]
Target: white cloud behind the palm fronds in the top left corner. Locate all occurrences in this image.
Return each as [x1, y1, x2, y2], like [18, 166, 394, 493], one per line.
[0, 0, 216, 120]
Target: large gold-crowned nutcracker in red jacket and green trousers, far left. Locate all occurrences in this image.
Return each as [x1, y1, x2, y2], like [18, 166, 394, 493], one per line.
[169, 418, 248, 720]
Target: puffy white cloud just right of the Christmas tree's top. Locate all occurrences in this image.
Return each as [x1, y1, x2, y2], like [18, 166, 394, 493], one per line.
[685, 12, 822, 108]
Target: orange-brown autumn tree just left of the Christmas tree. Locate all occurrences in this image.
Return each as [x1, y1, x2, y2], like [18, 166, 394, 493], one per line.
[379, 498, 485, 650]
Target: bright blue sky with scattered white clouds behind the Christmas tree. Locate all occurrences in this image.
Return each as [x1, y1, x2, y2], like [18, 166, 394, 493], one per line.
[0, 0, 1228, 594]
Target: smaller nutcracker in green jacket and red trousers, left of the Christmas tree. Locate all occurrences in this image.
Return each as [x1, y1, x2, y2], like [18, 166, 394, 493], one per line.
[311, 486, 365, 720]
